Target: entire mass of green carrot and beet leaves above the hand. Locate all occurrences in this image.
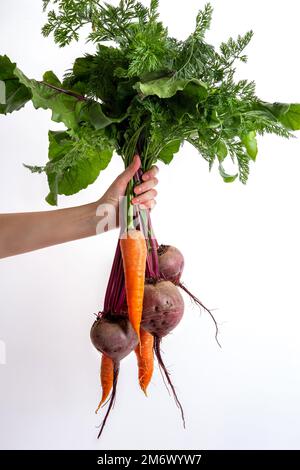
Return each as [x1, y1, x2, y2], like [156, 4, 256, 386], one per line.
[0, 0, 300, 204]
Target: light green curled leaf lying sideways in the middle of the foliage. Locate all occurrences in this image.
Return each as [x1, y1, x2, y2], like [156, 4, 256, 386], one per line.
[134, 77, 207, 98]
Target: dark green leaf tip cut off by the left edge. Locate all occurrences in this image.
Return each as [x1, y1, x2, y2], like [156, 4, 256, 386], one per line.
[0, 56, 32, 114]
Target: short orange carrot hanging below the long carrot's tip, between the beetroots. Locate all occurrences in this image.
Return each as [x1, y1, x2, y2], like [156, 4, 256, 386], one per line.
[135, 328, 154, 396]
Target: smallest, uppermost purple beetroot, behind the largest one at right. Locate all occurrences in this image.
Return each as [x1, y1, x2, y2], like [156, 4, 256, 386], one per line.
[157, 245, 184, 284]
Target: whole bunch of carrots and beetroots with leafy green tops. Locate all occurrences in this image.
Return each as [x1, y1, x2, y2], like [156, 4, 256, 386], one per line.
[0, 0, 300, 436]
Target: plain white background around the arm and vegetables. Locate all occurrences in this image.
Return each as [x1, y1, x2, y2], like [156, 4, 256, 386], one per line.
[0, 0, 300, 449]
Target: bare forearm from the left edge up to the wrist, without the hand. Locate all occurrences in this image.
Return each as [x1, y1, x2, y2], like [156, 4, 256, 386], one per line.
[0, 203, 101, 258]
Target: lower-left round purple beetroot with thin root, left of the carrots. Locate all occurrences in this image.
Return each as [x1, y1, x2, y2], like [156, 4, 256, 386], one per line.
[91, 315, 138, 363]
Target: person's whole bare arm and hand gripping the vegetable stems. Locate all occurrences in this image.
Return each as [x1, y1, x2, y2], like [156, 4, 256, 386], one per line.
[0, 157, 157, 258]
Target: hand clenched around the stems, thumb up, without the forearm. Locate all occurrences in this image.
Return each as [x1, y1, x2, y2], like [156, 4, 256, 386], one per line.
[99, 155, 158, 212]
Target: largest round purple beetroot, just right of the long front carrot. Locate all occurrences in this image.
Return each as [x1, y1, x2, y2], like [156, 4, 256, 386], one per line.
[141, 281, 184, 338]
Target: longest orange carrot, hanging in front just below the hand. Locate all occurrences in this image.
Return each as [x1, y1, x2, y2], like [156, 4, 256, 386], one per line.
[120, 229, 147, 339]
